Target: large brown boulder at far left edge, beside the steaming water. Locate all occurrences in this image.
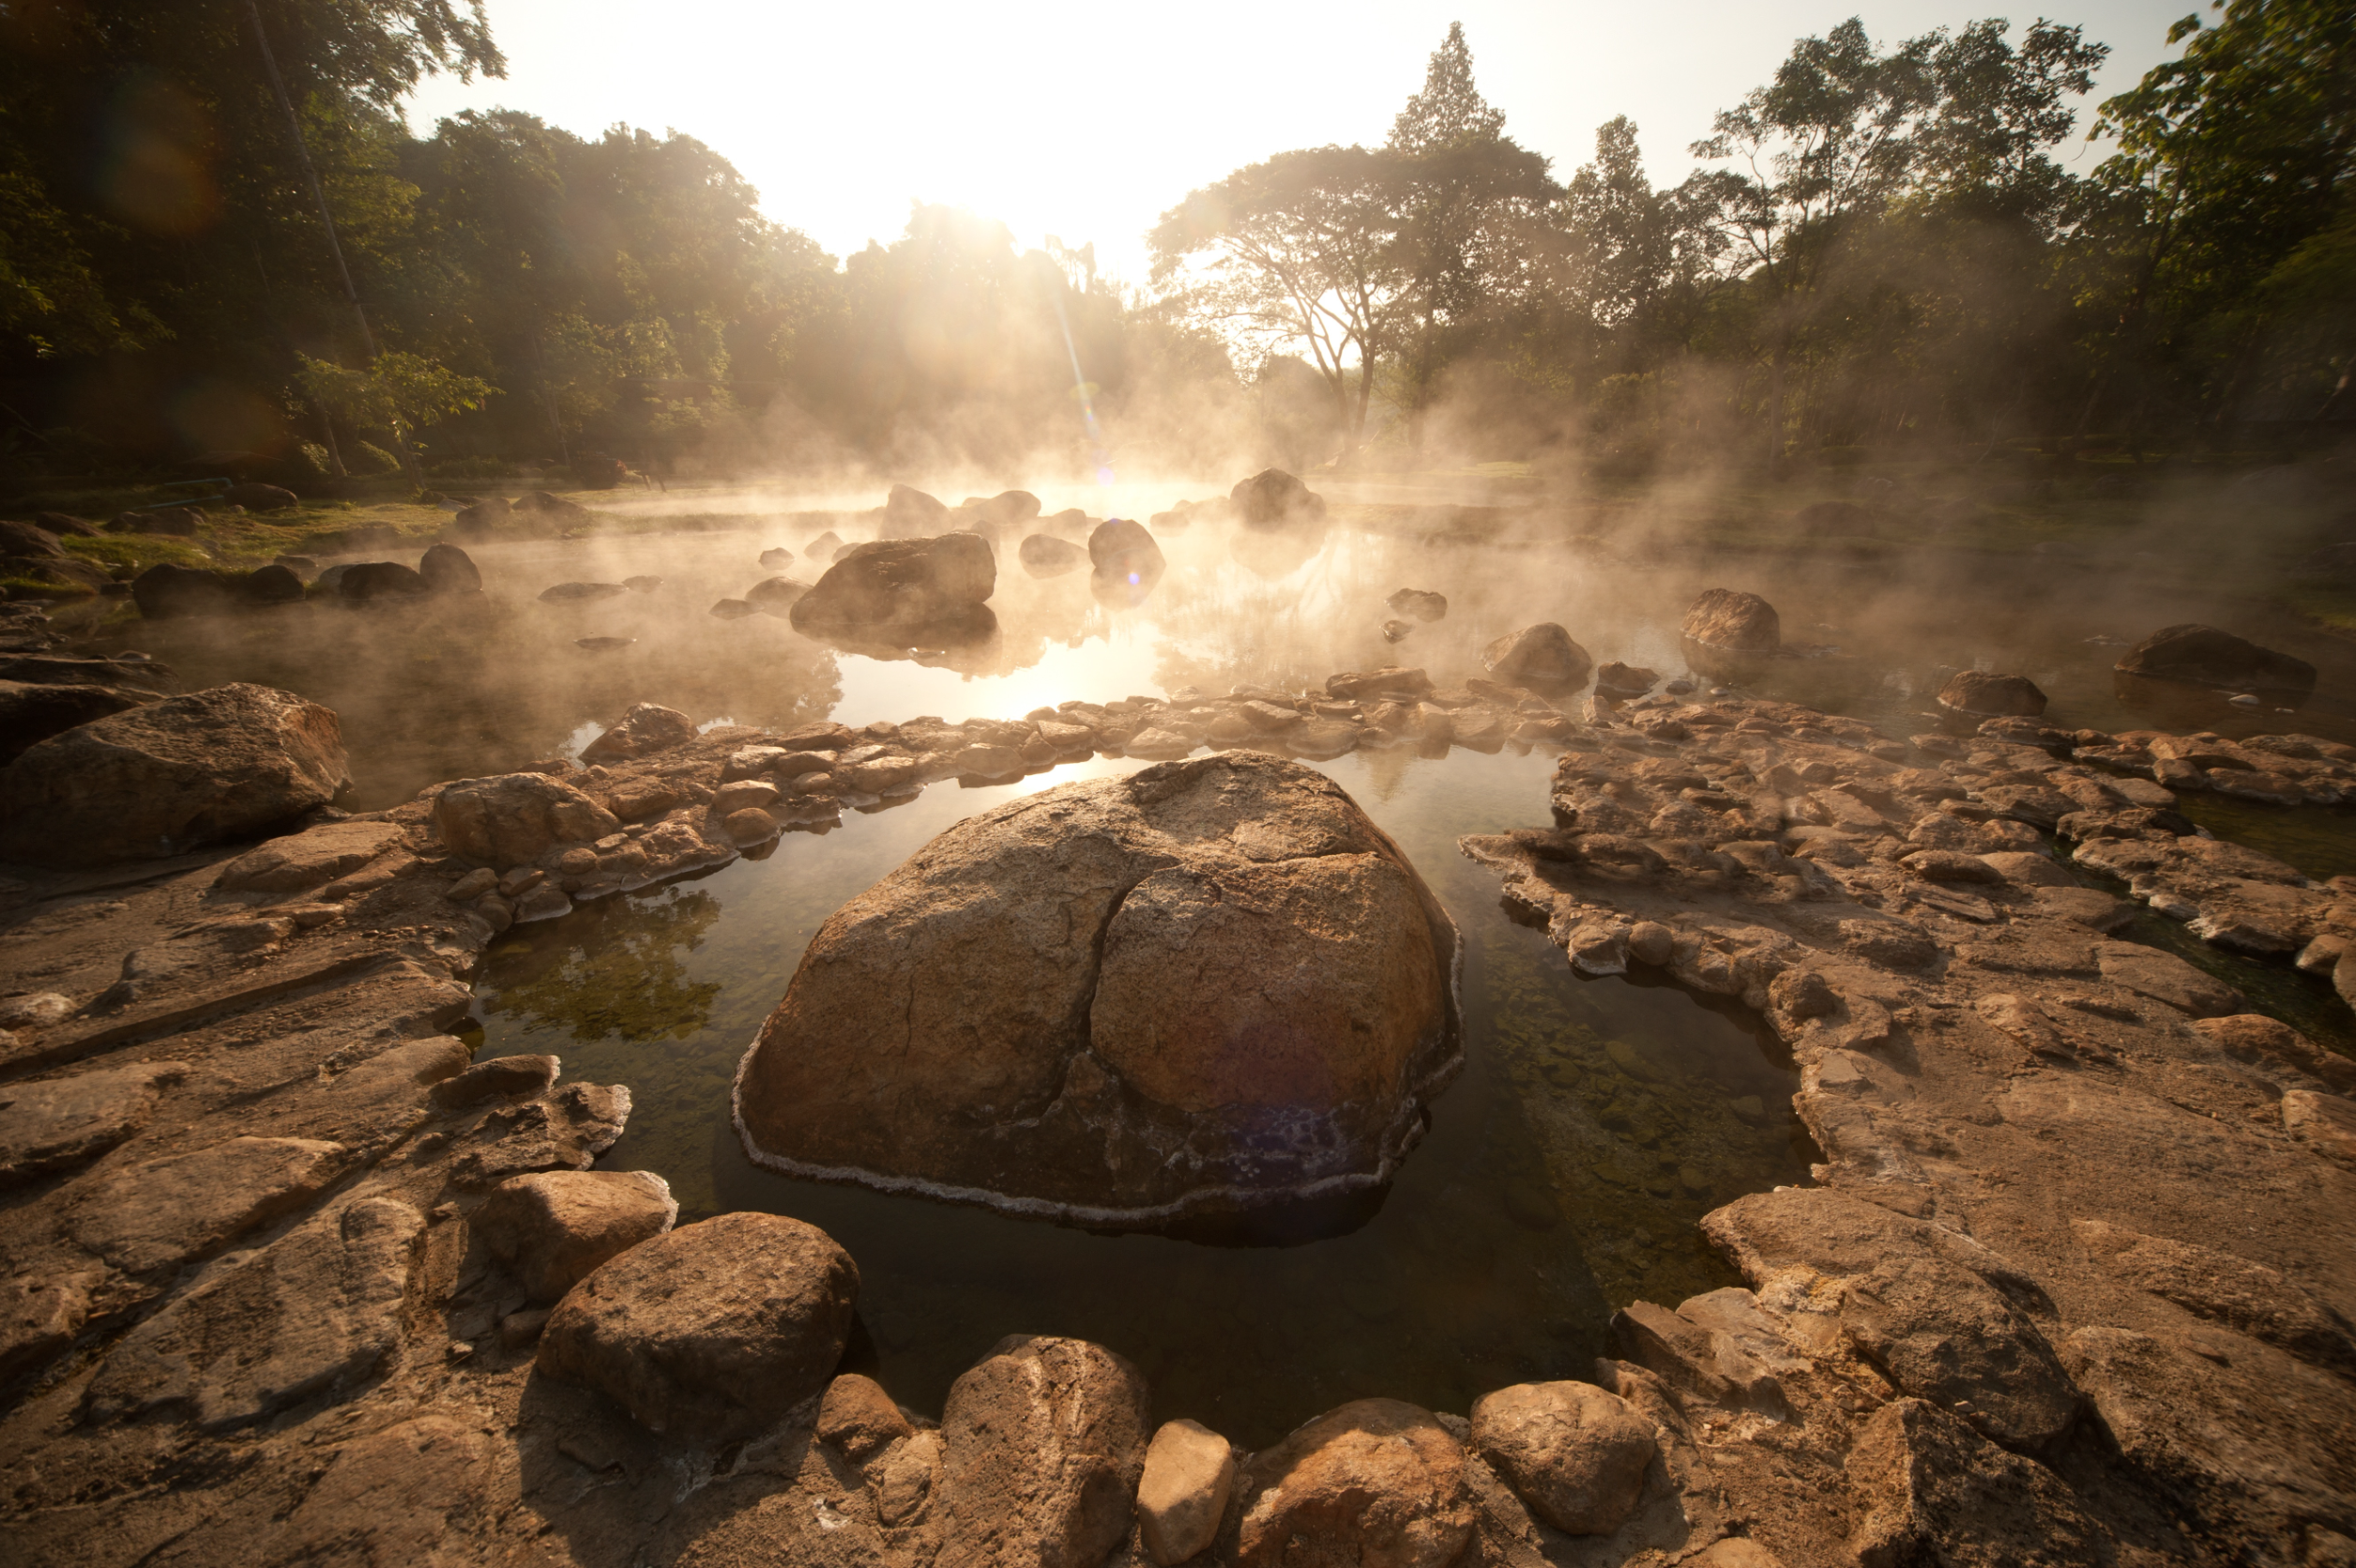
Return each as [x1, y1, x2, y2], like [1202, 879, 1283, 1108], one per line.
[0, 681, 351, 865]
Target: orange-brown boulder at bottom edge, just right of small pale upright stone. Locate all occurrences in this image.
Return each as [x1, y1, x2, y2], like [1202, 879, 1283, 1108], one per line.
[1237, 1398, 1472, 1568]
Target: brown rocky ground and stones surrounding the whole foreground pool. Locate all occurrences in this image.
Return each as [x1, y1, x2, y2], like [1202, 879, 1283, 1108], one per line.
[0, 670, 2356, 1568]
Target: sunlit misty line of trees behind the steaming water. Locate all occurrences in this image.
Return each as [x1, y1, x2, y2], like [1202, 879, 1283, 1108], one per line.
[0, 0, 2356, 479]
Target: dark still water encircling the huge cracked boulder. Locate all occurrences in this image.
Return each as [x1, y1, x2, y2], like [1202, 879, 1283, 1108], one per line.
[468, 753, 1814, 1445]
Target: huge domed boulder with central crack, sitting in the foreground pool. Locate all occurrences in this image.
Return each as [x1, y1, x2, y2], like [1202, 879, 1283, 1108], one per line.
[735, 753, 1461, 1224]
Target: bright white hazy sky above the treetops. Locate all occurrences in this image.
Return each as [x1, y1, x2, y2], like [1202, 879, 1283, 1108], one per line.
[410, 0, 2194, 283]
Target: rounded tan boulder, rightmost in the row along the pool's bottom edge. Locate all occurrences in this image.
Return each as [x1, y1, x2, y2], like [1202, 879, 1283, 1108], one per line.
[1472, 1381, 1656, 1535]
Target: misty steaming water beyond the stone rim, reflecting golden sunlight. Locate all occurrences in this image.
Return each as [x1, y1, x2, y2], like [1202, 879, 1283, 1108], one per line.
[91, 488, 2356, 820]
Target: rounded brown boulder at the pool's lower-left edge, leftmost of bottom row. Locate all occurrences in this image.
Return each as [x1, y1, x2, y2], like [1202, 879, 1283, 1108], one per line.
[535, 1212, 860, 1440]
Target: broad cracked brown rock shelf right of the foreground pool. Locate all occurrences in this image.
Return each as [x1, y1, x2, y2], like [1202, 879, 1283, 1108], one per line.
[1461, 698, 2356, 1563]
